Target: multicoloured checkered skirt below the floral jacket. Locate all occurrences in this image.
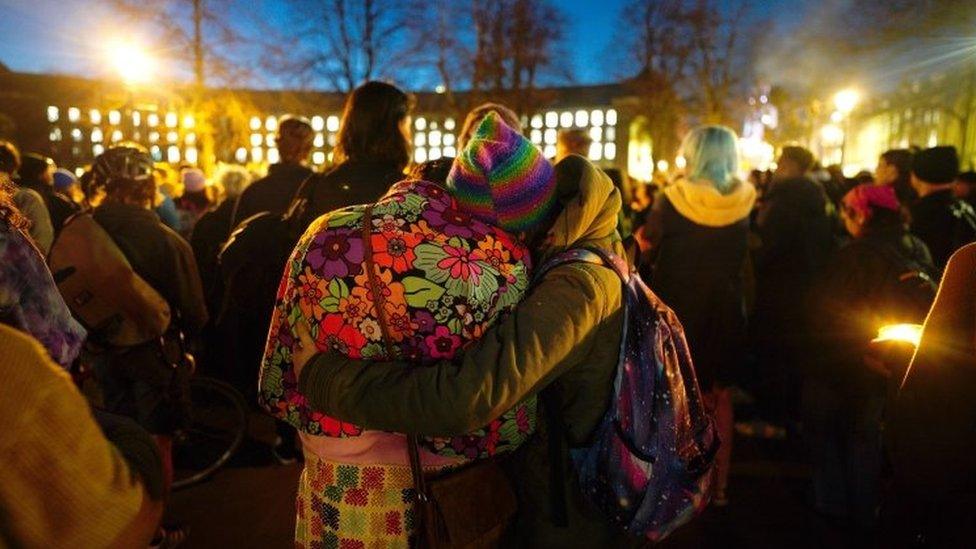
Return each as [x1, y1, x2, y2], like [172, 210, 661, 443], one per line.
[295, 452, 415, 549]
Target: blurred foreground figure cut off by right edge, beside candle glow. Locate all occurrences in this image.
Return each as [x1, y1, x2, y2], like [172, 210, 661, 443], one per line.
[883, 244, 976, 547]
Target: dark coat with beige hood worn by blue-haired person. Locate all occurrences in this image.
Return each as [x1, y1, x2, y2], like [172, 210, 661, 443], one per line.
[651, 181, 756, 389]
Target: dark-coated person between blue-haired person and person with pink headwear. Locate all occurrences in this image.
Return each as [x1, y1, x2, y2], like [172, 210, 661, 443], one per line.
[752, 147, 833, 422]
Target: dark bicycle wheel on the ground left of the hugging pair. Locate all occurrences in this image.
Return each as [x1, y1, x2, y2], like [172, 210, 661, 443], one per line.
[173, 377, 247, 490]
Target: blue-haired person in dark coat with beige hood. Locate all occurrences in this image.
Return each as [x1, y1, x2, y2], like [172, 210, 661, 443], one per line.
[648, 126, 756, 505]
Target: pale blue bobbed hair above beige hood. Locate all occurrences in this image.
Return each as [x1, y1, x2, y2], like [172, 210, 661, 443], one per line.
[681, 126, 739, 194]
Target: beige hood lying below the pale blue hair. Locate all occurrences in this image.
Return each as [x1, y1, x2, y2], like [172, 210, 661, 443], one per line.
[664, 180, 756, 227]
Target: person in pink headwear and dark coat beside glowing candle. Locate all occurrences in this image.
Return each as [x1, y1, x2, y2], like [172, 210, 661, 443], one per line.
[803, 185, 935, 535]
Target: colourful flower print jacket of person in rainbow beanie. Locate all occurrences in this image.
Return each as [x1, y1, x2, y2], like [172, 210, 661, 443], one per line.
[259, 181, 535, 459]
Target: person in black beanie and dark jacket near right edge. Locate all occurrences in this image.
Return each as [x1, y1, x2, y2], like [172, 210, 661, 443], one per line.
[910, 146, 976, 272]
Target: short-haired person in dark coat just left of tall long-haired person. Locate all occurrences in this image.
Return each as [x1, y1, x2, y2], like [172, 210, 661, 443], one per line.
[233, 116, 314, 227]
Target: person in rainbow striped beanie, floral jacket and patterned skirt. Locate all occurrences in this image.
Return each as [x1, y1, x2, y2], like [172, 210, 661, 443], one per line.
[259, 114, 556, 546]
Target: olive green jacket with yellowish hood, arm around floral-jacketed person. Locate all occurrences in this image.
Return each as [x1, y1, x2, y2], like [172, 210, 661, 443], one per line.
[299, 157, 623, 547]
